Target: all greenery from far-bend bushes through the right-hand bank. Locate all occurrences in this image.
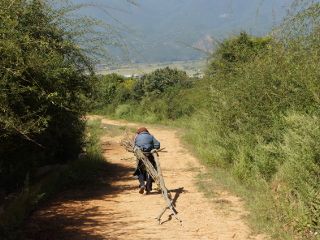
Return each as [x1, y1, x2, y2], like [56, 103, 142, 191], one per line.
[96, 1, 320, 239]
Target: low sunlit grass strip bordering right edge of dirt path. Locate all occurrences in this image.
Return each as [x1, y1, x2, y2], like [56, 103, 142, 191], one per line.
[173, 120, 282, 236]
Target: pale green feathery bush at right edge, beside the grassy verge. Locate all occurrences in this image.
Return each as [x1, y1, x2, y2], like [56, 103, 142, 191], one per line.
[273, 112, 320, 235]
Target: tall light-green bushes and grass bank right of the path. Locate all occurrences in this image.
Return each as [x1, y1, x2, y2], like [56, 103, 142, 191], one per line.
[180, 31, 320, 239]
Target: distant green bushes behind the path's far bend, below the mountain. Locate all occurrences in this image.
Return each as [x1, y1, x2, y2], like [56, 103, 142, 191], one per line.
[96, 68, 195, 122]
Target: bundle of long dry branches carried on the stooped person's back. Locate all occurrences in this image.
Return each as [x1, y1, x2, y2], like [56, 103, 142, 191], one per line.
[120, 133, 182, 224]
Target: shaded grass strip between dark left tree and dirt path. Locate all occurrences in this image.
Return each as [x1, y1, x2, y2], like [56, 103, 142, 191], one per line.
[0, 120, 106, 240]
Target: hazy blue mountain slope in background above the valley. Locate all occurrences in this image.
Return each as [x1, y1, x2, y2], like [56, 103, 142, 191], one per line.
[74, 0, 292, 62]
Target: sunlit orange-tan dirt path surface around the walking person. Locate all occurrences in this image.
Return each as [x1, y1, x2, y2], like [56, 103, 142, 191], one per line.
[28, 119, 265, 240]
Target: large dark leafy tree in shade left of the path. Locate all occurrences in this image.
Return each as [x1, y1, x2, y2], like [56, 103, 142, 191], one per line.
[0, 0, 94, 191]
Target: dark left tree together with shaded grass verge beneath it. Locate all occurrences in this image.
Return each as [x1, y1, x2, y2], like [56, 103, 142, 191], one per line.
[0, 0, 115, 239]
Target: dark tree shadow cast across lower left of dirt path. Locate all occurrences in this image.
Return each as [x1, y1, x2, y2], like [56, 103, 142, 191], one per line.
[22, 162, 135, 240]
